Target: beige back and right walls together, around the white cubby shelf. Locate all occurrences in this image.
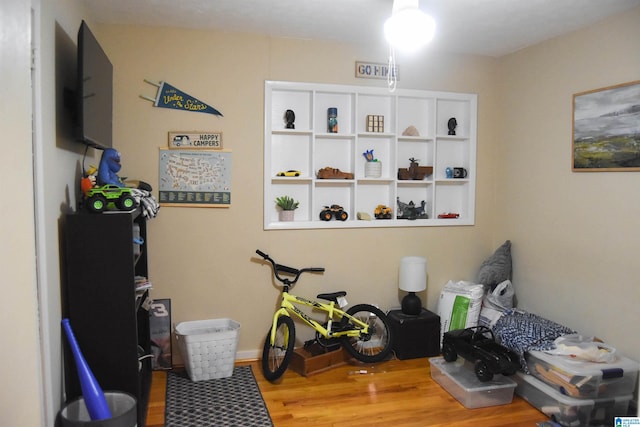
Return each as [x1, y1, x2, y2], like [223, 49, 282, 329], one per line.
[101, 10, 640, 361]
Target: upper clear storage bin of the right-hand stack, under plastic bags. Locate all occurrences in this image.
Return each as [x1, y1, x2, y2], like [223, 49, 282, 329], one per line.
[525, 351, 640, 399]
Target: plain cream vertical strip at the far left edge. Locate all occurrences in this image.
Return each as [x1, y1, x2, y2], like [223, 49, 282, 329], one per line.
[0, 0, 42, 426]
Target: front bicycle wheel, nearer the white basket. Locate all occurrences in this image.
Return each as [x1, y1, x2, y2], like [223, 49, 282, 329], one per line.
[262, 316, 296, 382]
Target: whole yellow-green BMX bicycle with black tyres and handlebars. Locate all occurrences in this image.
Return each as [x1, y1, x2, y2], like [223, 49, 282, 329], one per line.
[256, 250, 392, 382]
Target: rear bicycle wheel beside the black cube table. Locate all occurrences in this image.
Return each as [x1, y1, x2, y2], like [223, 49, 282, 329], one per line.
[342, 304, 393, 363]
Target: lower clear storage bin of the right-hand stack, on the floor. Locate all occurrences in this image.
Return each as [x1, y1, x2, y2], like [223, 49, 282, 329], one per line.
[514, 372, 633, 427]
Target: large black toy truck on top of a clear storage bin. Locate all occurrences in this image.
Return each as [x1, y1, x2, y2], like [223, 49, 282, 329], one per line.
[442, 326, 520, 382]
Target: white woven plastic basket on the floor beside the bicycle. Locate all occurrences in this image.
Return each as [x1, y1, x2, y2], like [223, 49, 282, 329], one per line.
[175, 319, 240, 381]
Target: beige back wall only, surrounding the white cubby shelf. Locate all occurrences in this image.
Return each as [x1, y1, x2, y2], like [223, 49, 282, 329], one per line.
[100, 26, 498, 357]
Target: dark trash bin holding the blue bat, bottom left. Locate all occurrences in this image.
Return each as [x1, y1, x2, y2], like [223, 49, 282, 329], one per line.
[60, 391, 138, 427]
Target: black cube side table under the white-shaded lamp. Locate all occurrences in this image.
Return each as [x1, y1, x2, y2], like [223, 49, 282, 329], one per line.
[388, 309, 440, 359]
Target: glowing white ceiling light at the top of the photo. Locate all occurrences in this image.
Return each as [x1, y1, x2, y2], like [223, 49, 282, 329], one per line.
[384, 0, 436, 52]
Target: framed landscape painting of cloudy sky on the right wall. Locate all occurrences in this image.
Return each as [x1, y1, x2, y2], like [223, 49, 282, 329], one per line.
[572, 80, 640, 172]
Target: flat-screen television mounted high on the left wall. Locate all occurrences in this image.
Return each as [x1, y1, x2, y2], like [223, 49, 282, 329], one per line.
[76, 21, 113, 150]
